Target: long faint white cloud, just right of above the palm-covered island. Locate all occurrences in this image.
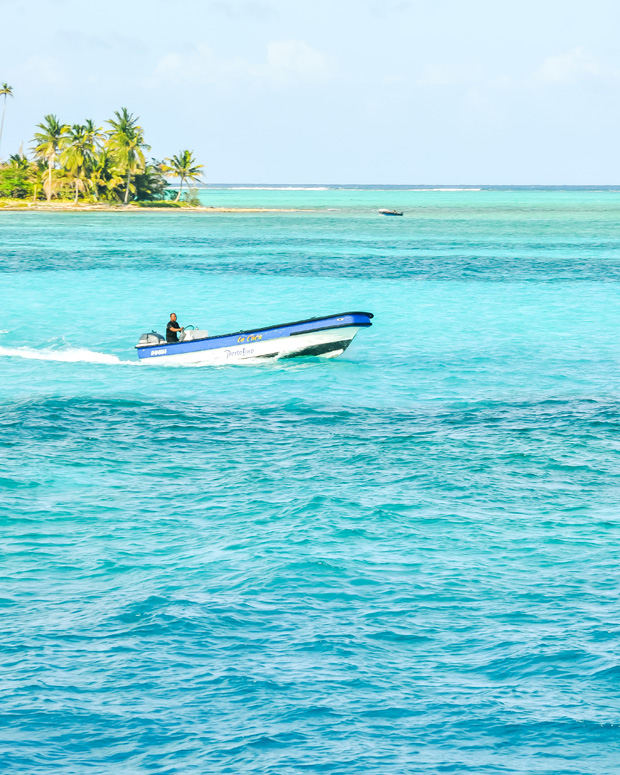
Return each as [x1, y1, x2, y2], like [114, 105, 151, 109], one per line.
[148, 40, 337, 86]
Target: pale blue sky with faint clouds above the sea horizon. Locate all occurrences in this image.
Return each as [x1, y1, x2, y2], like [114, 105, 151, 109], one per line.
[0, 0, 620, 185]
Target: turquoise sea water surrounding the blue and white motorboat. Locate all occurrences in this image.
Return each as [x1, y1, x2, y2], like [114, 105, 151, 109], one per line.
[0, 187, 620, 775]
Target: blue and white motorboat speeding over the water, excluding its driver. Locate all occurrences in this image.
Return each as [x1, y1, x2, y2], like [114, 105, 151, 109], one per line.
[136, 312, 373, 365]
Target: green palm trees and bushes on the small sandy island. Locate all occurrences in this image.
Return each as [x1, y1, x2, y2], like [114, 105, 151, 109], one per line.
[0, 94, 203, 207]
